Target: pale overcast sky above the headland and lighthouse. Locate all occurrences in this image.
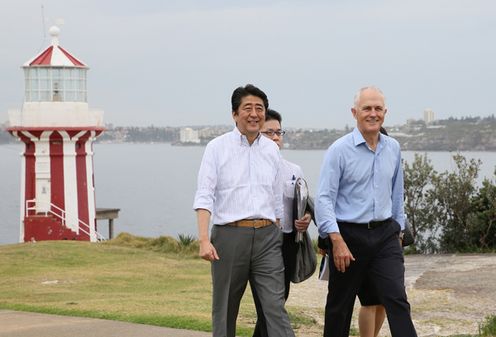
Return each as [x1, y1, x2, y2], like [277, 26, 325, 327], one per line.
[0, 0, 496, 128]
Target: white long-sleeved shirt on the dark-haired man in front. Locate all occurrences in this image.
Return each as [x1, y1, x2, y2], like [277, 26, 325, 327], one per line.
[193, 128, 283, 225]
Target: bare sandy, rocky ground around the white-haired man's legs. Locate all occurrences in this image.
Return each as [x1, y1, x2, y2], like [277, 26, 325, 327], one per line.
[287, 254, 496, 337]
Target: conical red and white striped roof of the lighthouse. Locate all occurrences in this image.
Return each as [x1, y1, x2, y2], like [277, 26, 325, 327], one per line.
[23, 26, 87, 68]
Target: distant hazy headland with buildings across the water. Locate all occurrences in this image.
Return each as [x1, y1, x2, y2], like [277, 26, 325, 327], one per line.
[0, 115, 496, 151]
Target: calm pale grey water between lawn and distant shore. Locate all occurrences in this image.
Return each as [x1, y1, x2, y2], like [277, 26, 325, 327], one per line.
[0, 143, 496, 244]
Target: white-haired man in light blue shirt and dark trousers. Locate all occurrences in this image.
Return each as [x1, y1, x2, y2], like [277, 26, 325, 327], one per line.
[315, 87, 417, 337]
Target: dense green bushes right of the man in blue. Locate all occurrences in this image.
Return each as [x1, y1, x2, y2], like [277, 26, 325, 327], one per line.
[403, 154, 496, 253]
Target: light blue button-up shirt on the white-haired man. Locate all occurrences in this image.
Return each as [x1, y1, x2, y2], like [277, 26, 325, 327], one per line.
[315, 128, 405, 237]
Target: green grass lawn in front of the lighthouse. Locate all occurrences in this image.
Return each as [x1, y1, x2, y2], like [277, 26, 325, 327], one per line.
[0, 235, 313, 336]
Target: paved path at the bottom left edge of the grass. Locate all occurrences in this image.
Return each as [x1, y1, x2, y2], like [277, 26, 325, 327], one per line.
[0, 310, 211, 337]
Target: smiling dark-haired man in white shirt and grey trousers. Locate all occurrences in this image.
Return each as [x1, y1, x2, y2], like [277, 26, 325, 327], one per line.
[193, 84, 294, 337]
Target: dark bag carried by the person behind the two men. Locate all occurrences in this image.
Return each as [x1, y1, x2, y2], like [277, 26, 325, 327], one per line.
[291, 178, 317, 283]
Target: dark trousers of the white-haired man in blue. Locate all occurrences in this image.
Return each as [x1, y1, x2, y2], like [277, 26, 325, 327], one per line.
[324, 220, 417, 337]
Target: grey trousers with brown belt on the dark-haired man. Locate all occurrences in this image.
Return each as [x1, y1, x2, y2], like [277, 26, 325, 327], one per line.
[211, 225, 294, 337]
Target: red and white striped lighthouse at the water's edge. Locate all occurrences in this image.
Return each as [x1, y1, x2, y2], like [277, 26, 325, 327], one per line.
[8, 26, 104, 242]
